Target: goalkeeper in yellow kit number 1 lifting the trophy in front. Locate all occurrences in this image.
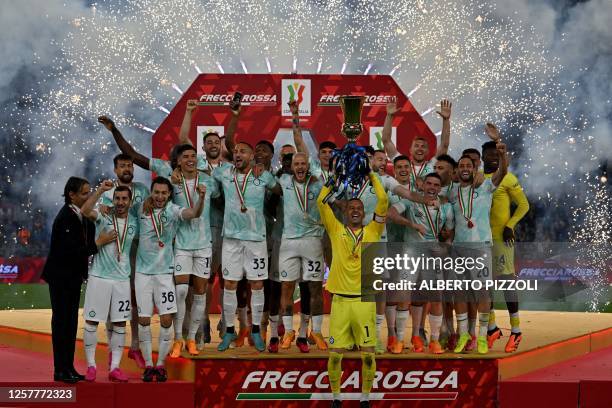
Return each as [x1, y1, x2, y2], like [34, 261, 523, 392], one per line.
[317, 172, 388, 408]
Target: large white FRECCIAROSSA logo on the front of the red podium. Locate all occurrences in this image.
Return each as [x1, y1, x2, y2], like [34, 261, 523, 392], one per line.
[236, 370, 459, 401]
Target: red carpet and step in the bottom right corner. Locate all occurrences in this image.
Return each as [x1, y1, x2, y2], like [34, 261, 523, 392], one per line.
[499, 347, 612, 408]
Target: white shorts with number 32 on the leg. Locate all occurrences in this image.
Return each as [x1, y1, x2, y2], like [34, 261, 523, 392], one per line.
[278, 237, 325, 282]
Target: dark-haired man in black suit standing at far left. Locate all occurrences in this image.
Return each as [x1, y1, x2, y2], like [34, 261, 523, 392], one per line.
[42, 177, 97, 383]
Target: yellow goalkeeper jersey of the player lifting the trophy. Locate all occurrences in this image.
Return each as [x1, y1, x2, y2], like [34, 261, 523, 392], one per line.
[317, 173, 388, 295]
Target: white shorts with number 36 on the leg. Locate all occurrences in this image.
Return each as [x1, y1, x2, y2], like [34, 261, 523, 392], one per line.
[134, 272, 176, 317]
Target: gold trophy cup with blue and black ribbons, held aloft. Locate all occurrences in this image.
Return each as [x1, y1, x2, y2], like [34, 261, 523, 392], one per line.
[330, 95, 370, 197]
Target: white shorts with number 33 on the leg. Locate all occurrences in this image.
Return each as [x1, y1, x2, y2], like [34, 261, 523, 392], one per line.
[221, 238, 268, 281]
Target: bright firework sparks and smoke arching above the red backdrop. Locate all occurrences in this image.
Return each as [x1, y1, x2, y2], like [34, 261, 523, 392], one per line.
[5, 0, 610, 302]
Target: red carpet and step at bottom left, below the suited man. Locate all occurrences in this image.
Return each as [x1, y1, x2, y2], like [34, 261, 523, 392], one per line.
[0, 345, 194, 408]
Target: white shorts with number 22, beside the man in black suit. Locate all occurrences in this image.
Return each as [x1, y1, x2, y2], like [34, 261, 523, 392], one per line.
[83, 275, 132, 322]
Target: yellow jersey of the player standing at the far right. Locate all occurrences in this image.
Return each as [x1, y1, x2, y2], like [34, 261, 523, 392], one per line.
[484, 172, 529, 241]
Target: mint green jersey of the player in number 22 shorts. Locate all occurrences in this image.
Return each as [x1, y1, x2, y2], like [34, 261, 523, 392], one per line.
[89, 211, 138, 281]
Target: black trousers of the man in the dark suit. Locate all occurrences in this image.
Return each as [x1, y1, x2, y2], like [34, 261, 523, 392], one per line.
[49, 281, 81, 372]
